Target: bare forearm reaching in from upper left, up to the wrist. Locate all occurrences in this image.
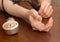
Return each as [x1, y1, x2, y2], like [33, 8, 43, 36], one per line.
[4, 0, 29, 19]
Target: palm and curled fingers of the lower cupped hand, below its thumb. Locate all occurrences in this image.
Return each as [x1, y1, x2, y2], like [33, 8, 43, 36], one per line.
[30, 16, 53, 32]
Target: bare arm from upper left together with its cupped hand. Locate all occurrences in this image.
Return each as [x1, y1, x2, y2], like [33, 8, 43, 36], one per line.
[0, 0, 52, 31]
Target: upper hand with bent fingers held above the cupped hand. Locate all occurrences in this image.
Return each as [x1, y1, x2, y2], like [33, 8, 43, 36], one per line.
[38, 1, 53, 18]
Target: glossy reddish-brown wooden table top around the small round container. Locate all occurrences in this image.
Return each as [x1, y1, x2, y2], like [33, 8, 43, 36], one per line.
[0, 2, 60, 42]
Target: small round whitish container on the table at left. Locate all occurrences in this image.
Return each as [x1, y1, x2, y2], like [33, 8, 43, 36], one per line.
[2, 18, 19, 35]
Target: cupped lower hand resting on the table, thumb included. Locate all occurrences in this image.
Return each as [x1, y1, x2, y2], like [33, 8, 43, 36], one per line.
[29, 10, 53, 32]
